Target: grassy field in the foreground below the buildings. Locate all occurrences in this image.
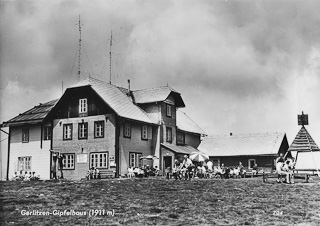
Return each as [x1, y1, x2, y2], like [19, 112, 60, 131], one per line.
[0, 178, 320, 225]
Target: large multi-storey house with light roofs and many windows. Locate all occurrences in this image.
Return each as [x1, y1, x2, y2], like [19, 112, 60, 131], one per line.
[4, 78, 205, 179]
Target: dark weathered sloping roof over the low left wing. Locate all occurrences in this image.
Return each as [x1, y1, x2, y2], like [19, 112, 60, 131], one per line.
[3, 100, 58, 126]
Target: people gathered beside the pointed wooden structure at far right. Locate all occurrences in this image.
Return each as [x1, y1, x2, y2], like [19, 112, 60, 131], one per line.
[276, 153, 296, 184]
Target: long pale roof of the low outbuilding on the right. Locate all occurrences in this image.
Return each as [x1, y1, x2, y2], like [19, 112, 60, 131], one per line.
[198, 133, 286, 156]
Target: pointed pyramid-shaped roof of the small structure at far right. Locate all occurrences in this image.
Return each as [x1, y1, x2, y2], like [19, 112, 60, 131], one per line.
[288, 126, 319, 151]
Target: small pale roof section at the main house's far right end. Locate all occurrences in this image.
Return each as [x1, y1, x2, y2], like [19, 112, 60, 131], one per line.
[177, 110, 206, 135]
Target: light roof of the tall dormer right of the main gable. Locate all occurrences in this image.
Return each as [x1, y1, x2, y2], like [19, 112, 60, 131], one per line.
[132, 86, 185, 107]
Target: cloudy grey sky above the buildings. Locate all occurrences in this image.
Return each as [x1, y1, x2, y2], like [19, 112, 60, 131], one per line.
[0, 0, 320, 145]
